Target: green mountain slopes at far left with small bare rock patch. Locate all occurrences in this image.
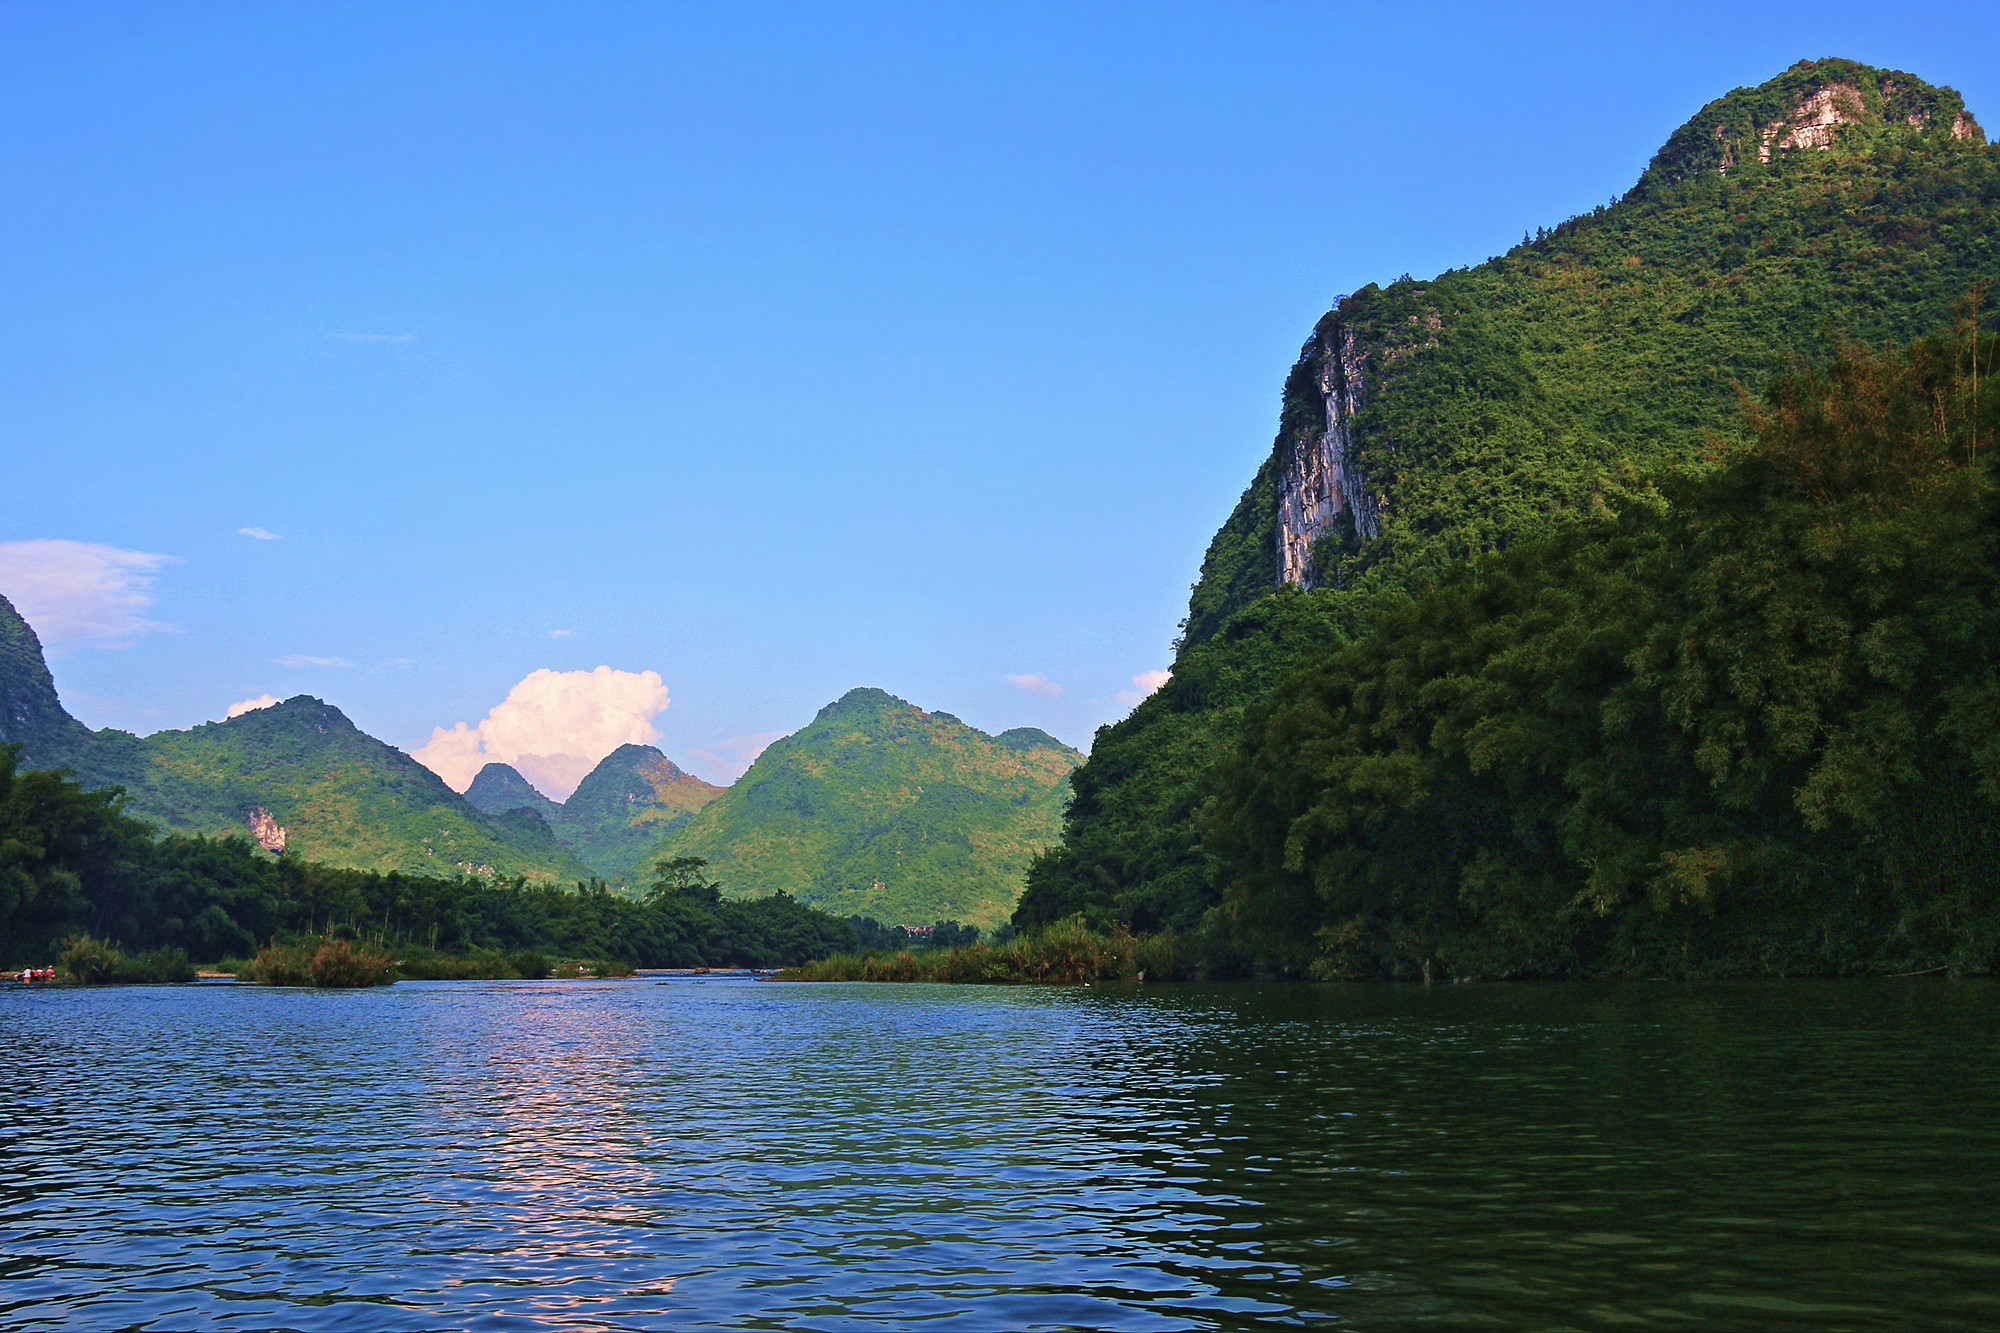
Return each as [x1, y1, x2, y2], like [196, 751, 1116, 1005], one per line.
[0, 596, 590, 879]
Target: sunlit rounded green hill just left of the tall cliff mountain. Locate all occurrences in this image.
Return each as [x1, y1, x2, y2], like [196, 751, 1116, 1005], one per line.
[656, 689, 1082, 927]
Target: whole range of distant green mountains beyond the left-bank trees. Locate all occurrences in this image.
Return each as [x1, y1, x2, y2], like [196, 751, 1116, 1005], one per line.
[0, 596, 1082, 912]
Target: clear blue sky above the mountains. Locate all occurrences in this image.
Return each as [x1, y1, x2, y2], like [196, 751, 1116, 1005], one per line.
[0, 0, 2000, 777]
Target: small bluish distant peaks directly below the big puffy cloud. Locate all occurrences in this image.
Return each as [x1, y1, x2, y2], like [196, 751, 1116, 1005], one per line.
[466, 745, 724, 885]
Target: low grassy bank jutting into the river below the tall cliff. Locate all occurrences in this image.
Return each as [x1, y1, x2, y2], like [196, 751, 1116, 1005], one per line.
[778, 917, 1180, 985]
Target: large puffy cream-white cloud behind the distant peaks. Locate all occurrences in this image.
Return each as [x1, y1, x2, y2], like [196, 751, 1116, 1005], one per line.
[412, 667, 670, 801]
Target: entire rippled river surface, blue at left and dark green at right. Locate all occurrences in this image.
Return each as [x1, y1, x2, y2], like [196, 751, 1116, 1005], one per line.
[0, 979, 2000, 1333]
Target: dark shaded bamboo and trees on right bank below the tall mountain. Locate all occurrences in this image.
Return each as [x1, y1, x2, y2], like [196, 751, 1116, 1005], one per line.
[1204, 330, 2000, 977]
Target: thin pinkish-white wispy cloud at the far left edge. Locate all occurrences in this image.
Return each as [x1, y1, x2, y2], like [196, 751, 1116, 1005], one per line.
[0, 540, 174, 648]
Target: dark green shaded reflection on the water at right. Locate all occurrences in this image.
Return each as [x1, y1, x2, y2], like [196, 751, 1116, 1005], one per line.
[1128, 983, 2000, 1329]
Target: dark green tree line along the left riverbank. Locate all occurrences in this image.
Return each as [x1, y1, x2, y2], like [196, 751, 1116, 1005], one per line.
[0, 747, 856, 967]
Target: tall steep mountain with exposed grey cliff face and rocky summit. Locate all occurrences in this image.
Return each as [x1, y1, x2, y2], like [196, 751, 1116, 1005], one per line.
[1016, 60, 2000, 929]
